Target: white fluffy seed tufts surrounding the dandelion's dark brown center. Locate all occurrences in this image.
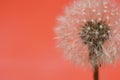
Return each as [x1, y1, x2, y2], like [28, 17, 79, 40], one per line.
[55, 0, 120, 67]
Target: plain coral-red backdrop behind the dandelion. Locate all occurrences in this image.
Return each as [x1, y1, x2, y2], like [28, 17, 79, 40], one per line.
[0, 0, 120, 80]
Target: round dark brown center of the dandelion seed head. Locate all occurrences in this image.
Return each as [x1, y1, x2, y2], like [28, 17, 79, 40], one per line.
[80, 21, 110, 45]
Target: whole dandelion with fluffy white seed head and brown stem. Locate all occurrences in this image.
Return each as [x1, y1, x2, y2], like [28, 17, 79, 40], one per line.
[55, 0, 120, 80]
